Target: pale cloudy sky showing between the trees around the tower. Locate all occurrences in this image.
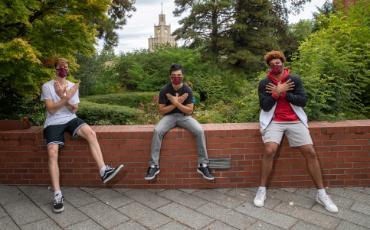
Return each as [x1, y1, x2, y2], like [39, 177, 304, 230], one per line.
[97, 0, 325, 54]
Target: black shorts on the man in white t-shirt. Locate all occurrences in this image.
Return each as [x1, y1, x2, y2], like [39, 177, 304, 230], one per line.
[44, 117, 86, 145]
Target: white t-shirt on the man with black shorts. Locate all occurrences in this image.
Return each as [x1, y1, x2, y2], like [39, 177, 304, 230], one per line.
[41, 80, 80, 128]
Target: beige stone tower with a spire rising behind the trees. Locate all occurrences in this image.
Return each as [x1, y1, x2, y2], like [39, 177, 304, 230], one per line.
[148, 4, 176, 51]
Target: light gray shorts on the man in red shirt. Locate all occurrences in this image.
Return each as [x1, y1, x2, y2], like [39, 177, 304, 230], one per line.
[261, 121, 312, 147]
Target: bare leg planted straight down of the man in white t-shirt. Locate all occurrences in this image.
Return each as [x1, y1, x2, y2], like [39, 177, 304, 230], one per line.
[47, 144, 60, 192]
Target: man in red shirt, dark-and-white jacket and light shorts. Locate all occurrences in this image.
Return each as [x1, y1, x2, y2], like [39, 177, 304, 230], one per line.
[254, 51, 338, 212]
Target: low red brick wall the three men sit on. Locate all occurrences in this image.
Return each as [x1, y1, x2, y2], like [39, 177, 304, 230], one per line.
[0, 120, 370, 188]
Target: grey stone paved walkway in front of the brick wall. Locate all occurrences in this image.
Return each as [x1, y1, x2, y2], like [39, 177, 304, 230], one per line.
[0, 185, 370, 230]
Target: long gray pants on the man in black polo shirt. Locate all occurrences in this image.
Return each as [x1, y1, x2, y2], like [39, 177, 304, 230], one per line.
[149, 113, 208, 166]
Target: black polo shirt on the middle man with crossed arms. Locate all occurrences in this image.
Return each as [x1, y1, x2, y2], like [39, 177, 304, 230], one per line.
[159, 83, 193, 115]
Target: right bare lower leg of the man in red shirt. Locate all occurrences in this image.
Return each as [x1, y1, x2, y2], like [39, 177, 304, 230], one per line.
[298, 145, 324, 188]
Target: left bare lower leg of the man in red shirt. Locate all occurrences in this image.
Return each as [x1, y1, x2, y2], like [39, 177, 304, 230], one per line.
[260, 142, 279, 187]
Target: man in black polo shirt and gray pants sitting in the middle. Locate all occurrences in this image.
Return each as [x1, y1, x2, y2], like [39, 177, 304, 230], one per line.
[145, 64, 214, 180]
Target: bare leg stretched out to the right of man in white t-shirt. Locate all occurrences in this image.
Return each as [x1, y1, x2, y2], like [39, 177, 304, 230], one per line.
[77, 125, 105, 170]
